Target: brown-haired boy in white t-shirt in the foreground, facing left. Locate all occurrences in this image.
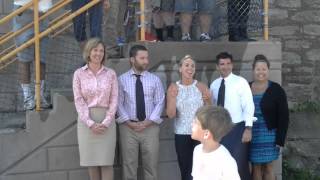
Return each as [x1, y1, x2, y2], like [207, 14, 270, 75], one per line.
[191, 105, 240, 180]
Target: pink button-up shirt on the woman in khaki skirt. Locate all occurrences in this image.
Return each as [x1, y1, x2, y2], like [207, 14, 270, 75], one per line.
[73, 65, 118, 127]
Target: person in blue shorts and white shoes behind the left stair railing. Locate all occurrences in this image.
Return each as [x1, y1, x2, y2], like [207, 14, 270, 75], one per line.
[13, 0, 52, 110]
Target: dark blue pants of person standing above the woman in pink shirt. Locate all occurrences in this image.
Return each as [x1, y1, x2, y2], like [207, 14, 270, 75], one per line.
[71, 0, 103, 42]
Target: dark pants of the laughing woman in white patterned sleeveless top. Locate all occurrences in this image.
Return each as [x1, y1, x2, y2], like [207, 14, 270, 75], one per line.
[175, 134, 199, 180]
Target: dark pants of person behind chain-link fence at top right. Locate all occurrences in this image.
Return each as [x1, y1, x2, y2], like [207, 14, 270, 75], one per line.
[228, 0, 250, 41]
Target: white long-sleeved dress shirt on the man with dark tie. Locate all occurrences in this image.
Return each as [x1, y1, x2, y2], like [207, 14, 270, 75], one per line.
[210, 73, 256, 126]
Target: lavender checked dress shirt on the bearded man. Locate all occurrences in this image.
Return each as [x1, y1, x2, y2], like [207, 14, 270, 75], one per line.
[117, 69, 165, 124]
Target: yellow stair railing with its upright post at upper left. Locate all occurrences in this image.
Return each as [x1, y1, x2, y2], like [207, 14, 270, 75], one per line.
[0, 0, 100, 111]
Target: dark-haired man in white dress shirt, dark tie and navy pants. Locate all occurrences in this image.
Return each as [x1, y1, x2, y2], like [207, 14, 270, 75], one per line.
[210, 52, 255, 180]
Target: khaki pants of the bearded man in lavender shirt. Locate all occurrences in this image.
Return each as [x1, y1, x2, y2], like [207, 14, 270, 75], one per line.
[119, 124, 160, 180]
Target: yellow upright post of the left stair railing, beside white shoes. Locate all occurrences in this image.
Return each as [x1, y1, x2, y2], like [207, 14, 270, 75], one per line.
[33, 0, 41, 111]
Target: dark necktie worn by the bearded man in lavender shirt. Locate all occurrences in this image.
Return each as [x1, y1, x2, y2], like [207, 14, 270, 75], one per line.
[135, 74, 146, 121]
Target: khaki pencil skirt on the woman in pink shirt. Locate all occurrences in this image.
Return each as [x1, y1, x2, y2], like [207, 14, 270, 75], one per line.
[77, 107, 116, 166]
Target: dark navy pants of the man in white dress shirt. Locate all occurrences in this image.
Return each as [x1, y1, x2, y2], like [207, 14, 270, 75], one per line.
[221, 122, 251, 180]
